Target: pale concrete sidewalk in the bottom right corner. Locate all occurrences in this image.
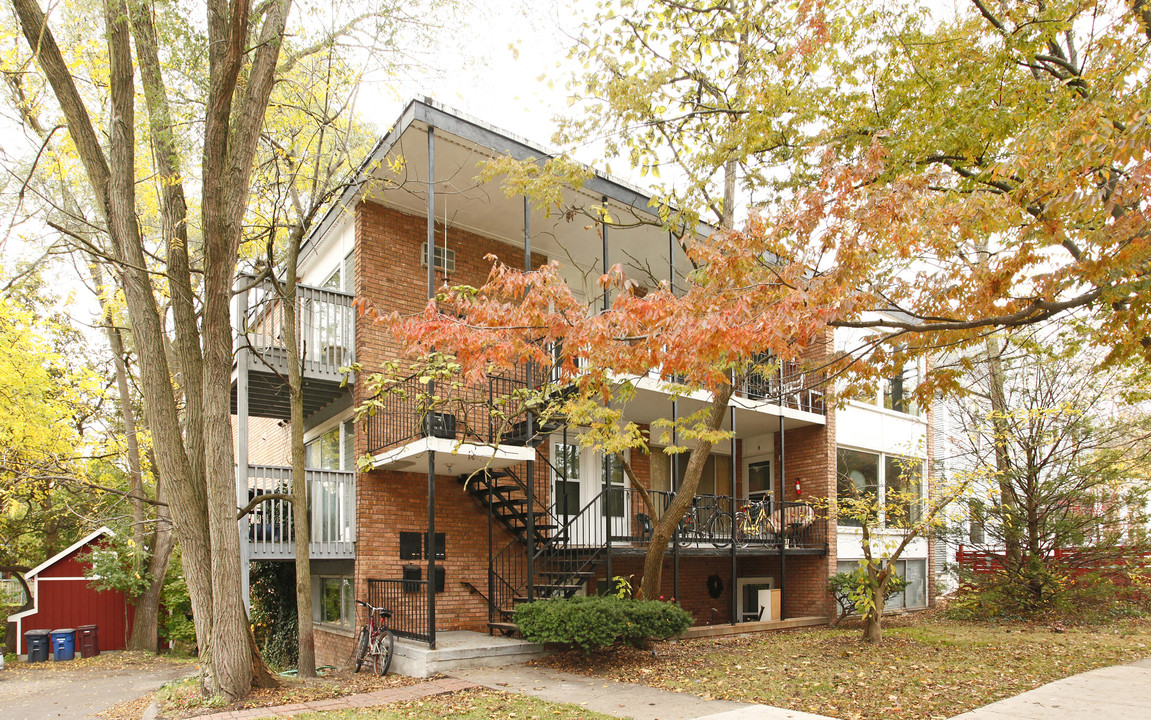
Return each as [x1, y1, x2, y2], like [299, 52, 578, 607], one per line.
[952, 658, 1151, 720]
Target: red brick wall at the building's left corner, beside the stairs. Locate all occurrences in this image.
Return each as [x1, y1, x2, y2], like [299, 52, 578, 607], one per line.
[355, 202, 549, 630]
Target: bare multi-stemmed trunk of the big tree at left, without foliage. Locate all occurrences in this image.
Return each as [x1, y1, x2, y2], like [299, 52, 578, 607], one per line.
[12, 0, 290, 697]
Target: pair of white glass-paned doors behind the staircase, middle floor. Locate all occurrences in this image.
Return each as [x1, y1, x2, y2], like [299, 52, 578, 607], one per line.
[551, 441, 630, 545]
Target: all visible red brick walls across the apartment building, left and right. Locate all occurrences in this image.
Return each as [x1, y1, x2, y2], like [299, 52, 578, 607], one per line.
[349, 197, 834, 625]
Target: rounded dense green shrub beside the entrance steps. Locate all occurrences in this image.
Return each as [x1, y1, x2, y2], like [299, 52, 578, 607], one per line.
[514, 596, 693, 652]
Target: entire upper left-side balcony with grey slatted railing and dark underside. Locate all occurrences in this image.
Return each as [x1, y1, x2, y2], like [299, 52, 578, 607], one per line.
[231, 276, 356, 420]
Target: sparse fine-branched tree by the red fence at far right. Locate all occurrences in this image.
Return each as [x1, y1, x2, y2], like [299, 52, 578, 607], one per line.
[947, 331, 1151, 614]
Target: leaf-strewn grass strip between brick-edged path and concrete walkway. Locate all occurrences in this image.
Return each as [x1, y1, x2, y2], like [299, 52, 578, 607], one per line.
[284, 689, 611, 720]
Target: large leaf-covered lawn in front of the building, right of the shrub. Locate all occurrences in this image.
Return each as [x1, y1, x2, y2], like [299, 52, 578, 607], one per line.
[540, 613, 1151, 720]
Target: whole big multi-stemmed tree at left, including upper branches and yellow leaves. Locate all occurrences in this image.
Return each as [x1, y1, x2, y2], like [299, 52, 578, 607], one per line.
[6, 0, 448, 697]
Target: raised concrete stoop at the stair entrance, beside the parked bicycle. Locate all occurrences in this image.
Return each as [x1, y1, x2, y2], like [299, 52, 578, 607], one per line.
[390, 630, 546, 677]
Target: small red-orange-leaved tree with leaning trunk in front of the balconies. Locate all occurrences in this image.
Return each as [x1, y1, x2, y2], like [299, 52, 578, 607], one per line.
[364, 219, 839, 598]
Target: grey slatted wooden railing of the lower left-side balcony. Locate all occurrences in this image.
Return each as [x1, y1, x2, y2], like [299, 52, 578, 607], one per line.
[241, 465, 356, 560]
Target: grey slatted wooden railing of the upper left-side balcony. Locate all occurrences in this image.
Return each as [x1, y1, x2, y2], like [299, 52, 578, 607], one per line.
[241, 276, 356, 376]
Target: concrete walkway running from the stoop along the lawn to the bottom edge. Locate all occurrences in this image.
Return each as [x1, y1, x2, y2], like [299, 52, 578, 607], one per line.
[452, 666, 829, 720]
